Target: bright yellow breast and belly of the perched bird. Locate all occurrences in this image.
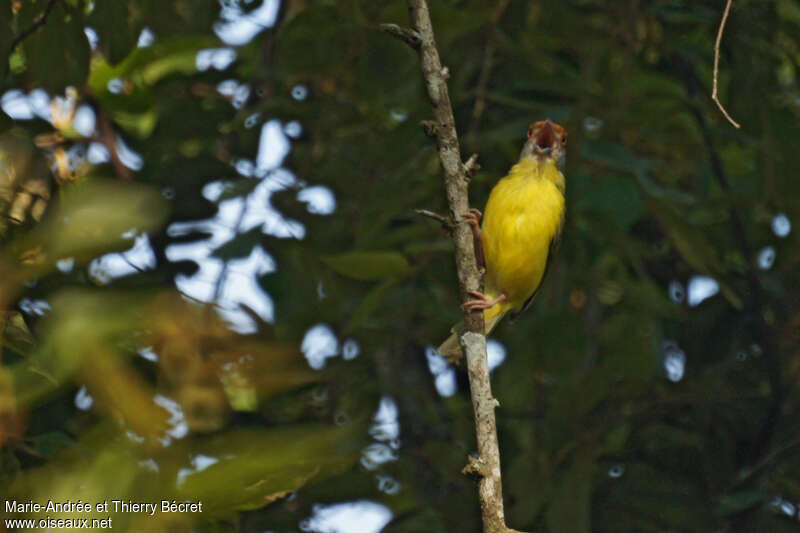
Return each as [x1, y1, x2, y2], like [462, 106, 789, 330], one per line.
[481, 157, 564, 319]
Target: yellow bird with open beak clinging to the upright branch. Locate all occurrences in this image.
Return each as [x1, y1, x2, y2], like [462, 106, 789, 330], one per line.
[439, 120, 567, 360]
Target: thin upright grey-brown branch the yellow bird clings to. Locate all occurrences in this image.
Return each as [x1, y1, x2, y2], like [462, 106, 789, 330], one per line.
[384, 0, 513, 533]
